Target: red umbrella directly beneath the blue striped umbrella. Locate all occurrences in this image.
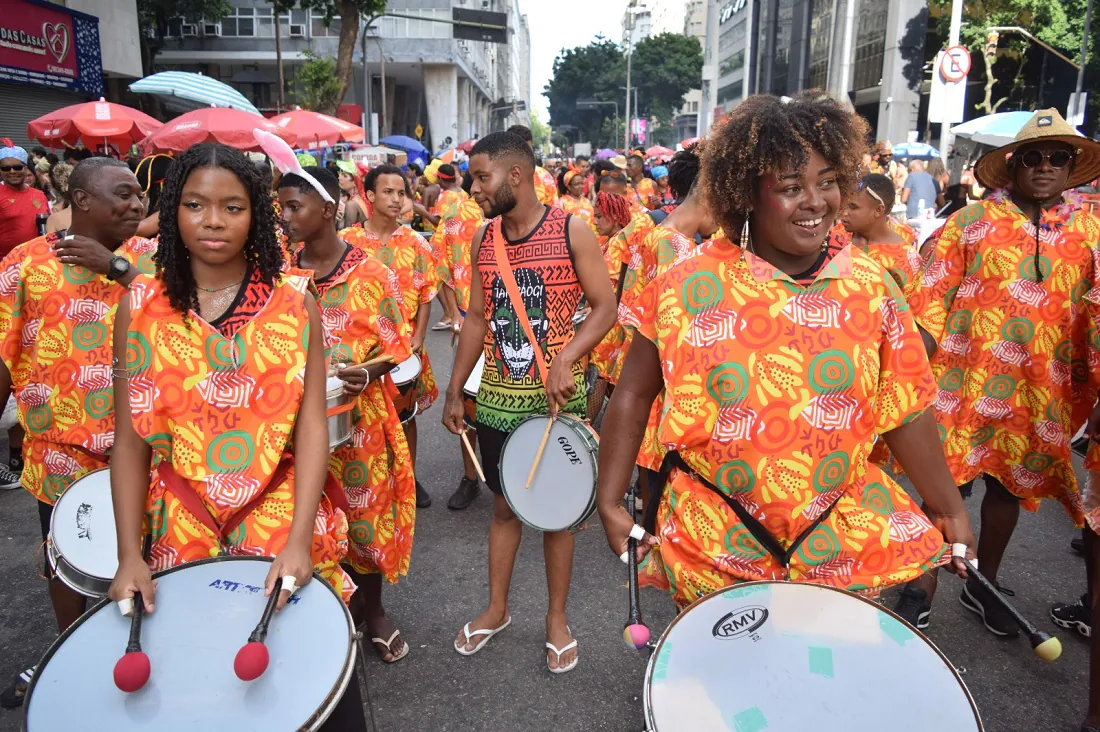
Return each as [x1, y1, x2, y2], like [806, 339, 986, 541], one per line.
[141, 107, 297, 153]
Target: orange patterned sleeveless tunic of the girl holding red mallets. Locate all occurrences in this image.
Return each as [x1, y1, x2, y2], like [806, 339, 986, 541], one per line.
[125, 275, 355, 601]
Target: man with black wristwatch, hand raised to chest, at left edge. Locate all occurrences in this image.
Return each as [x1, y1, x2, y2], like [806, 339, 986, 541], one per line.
[0, 157, 155, 707]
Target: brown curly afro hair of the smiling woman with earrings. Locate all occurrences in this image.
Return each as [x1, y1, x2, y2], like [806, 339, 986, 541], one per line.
[699, 89, 870, 232]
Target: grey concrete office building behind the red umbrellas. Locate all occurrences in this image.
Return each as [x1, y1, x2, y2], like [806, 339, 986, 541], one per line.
[156, 0, 530, 150]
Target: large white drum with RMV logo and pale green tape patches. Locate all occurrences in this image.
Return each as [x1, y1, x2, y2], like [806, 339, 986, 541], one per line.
[642, 582, 982, 732]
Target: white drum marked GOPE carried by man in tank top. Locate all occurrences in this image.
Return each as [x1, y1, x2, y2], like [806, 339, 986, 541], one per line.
[499, 414, 600, 532]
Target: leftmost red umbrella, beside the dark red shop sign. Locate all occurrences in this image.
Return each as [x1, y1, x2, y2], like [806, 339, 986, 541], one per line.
[26, 98, 163, 150]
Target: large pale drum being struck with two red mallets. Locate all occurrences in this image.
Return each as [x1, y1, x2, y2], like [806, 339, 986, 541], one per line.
[23, 557, 355, 732]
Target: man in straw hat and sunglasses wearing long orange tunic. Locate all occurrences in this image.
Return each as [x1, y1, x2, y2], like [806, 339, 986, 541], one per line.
[898, 109, 1100, 651]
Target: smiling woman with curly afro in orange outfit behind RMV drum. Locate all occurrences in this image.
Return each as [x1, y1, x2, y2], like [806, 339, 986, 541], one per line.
[597, 92, 974, 608]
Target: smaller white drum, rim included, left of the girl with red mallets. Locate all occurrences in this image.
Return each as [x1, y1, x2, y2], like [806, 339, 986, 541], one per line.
[46, 468, 119, 598]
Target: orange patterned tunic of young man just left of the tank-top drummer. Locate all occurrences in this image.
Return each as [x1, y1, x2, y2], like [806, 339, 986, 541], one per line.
[340, 225, 439, 412]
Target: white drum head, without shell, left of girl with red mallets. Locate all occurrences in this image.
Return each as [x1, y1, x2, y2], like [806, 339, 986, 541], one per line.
[50, 468, 117, 581]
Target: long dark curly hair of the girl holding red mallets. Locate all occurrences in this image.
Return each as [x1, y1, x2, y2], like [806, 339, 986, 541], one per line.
[153, 142, 283, 314]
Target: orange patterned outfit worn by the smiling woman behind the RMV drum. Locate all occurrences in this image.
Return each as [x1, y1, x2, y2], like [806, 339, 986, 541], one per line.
[629, 239, 945, 607]
